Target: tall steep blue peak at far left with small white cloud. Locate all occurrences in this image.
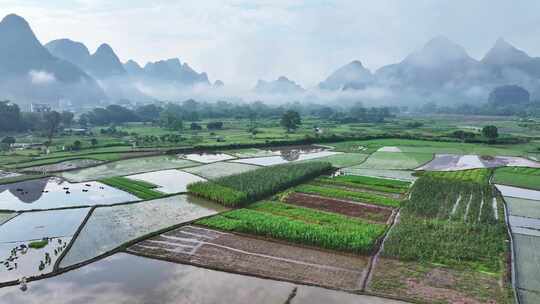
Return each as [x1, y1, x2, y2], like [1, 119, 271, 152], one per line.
[0, 15, 106, 103]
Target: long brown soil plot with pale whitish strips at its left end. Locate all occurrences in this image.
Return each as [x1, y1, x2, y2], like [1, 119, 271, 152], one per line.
[128, 226, 369, 290]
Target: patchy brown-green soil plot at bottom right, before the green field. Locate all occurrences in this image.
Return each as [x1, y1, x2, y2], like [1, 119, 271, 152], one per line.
[367, 258, 510, 304]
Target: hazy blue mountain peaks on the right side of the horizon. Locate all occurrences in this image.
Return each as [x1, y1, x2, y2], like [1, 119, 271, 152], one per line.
[319, 37, 540, 102]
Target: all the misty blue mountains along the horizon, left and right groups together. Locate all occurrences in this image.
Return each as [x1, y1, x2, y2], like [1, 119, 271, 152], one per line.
[0, 15, 540, 106]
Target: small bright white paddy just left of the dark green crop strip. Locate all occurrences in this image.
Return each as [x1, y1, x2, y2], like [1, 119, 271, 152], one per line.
[126, 169, 205, 194]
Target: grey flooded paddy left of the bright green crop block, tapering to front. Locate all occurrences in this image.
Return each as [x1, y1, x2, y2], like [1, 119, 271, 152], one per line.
[60, 195, 225, 268]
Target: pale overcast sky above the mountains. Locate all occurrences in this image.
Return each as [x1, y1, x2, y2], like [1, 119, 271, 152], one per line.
[0, 0, 540, 87]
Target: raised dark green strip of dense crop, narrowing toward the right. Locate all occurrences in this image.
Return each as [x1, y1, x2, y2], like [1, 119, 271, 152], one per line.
[188, 162, 332, 207]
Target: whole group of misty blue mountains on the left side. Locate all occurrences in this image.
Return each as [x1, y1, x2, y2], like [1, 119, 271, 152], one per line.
[0, 14, 215, 106]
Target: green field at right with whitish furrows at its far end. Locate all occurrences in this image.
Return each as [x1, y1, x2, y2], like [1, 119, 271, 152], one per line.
[383, 176, 507, 273]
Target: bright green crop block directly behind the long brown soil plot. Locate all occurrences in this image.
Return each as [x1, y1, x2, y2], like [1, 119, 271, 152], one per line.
[196, 202, 386, 254]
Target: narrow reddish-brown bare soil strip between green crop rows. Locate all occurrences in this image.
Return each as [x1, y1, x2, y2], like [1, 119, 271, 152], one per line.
[286, 193, 392, 223]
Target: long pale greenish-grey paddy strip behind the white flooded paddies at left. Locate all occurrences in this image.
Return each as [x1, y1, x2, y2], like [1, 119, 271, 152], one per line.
[61, 155, 197, 182]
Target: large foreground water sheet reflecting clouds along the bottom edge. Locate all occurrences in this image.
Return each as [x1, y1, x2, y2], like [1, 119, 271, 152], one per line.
[0, 253, 408, 304]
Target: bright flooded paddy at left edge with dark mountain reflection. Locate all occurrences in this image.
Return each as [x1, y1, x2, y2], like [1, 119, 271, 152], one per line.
[0, 177, 139, 211]
